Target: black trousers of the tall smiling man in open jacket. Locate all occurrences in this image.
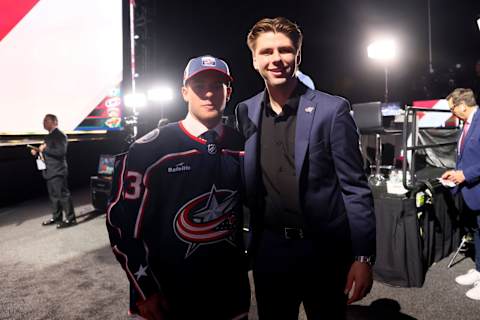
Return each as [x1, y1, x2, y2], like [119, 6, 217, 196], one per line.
[253, 230, 352, 320]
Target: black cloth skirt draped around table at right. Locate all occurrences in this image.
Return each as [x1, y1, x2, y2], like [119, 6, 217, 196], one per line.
[373, 188, 461, 287]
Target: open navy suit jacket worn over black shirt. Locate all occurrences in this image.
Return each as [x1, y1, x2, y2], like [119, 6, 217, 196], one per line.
[236, 89, 375, 256]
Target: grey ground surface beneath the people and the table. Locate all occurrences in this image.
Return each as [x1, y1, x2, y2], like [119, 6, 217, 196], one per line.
[0, 190, 480, 320]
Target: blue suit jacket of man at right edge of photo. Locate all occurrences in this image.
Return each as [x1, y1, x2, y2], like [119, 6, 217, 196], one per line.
[457, 110, 480, 211]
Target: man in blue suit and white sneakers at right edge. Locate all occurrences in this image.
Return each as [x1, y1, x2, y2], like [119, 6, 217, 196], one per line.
[442, 88, 480, 300]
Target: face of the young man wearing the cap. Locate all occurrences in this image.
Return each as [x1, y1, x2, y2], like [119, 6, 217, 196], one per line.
[182, 70, 232, 128]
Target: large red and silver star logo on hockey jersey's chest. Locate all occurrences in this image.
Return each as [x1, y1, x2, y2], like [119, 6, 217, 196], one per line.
[173, 185, 238, 258]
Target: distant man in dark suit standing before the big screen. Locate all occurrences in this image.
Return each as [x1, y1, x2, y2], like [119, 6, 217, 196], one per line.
[31, 114, 77, 228]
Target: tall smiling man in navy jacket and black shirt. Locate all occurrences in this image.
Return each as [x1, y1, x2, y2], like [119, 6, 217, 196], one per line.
[236, 17, 375, 320]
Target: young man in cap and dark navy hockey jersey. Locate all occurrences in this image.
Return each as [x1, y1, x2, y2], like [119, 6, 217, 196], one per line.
[107, 56, 250, 319]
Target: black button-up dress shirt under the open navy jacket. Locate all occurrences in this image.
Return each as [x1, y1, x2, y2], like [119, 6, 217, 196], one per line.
[260, 82, 306, 228]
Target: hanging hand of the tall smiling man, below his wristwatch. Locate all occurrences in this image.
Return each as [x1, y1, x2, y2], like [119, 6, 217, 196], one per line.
[345, 261, 373, 304]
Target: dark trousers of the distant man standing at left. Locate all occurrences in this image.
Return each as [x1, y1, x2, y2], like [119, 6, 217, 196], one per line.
[47, 176, 75, 221]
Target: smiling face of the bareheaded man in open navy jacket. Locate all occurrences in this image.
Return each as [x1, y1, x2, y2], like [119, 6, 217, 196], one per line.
[252, 32, 300, 87]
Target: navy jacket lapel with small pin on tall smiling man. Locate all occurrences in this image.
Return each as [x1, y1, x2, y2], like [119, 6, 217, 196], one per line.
[295, 89, 317, 180]
